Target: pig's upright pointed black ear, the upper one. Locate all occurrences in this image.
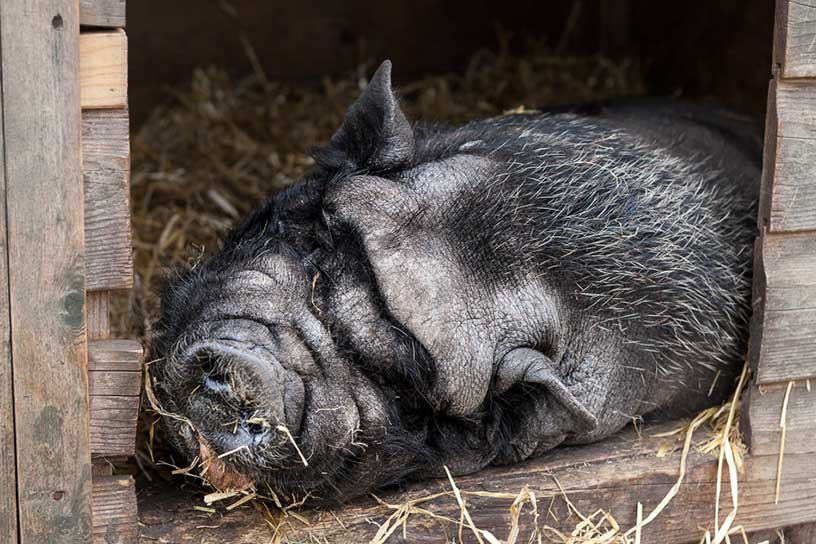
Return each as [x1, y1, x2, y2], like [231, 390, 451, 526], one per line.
[316, 60, 415, 172]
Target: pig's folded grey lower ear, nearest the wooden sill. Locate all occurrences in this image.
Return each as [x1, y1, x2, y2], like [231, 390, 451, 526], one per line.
[496, 348, 598, 432]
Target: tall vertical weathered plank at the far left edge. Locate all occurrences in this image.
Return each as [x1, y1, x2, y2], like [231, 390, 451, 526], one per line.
[0, 0, 91, 544]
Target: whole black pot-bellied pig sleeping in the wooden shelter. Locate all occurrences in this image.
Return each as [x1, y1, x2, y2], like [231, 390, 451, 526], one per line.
[150, 62, 761, 500]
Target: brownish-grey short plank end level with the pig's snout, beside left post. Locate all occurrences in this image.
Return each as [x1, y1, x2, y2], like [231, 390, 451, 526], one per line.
[88, 340, 142, 457]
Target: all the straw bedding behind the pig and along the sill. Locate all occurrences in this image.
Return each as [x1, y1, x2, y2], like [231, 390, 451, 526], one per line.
[124, 40, 760, 544]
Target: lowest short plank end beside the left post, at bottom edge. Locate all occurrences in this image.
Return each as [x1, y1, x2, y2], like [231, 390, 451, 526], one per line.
[93, 476, 139, 544]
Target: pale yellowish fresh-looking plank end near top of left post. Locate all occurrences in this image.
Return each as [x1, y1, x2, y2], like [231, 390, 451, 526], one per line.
[79, 30, 127, 109]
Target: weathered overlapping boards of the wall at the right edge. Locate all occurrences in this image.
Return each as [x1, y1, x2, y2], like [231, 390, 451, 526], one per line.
[745, 0, 816, 536]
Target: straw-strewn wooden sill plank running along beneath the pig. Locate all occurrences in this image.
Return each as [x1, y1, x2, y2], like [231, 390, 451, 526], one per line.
[139, 429, 816, 544]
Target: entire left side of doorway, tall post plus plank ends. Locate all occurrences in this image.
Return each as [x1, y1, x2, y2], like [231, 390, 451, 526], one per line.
[0, 0, 141, 544]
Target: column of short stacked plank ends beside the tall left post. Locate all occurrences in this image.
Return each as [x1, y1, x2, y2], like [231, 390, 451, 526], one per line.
[80, 5, 142, 544]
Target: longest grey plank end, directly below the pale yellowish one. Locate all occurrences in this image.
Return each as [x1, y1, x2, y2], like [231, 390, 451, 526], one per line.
[82, 109, 133, 291]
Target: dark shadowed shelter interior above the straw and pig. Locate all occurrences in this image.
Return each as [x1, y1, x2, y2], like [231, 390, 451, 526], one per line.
[128, 0, 774, 126]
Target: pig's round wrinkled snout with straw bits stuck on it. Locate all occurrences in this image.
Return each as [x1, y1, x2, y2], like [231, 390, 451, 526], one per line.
[190, 341, 304, 454]
